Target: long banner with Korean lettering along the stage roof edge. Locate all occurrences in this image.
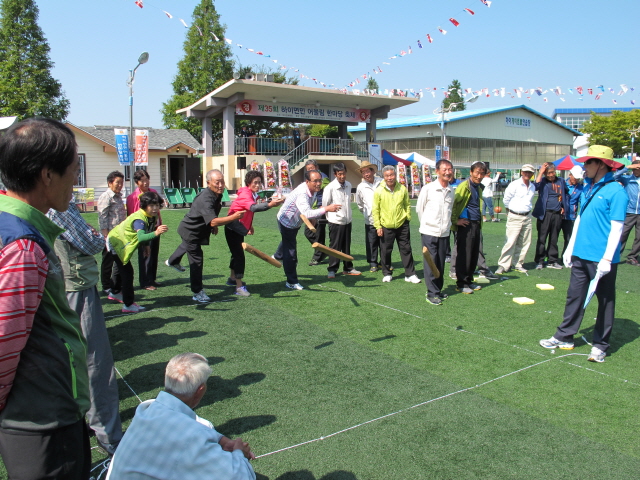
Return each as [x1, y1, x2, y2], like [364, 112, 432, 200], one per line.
[236, 100, 371, 123]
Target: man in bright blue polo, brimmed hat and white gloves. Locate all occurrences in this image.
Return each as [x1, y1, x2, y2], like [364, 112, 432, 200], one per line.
[540, 145, 629, 363]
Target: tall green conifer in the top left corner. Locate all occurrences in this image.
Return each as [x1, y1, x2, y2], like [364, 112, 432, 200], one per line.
[0, 0, 69, 120]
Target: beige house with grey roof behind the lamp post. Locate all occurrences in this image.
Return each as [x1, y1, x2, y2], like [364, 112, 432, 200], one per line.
[66, 122, 203, 205]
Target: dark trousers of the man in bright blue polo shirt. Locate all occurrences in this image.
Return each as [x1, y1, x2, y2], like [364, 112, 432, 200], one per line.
[554, 256, 618, 352]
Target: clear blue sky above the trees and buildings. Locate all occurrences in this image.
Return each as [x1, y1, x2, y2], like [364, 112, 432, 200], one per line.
[36, 0, 640, 127]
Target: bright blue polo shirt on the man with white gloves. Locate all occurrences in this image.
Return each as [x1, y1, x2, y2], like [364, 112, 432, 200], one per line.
[573, 172, 628, 263]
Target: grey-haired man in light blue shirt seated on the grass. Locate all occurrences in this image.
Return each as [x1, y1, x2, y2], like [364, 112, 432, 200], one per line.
[109, 353, 256, 480]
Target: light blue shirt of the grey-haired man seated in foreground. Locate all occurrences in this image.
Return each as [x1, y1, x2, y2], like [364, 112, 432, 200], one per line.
[110, 392, 256, 480]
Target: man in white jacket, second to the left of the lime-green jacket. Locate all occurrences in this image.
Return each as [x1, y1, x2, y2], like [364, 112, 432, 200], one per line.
[322, 163, 360, 278]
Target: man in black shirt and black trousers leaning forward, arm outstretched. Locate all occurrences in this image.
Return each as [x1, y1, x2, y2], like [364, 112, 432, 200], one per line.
[165, 170, 244, 303]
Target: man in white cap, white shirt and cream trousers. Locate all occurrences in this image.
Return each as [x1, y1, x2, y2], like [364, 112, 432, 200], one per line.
[496, 163, 536, 275]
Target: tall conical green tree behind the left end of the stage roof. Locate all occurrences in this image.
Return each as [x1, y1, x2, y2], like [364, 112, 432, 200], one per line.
[160, 0, 233, 139]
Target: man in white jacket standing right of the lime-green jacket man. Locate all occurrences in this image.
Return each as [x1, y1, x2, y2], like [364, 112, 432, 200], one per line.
[416, 160, 453, 305]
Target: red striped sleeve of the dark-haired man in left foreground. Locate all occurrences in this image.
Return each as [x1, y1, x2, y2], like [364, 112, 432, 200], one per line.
[0, 238, 49, 410]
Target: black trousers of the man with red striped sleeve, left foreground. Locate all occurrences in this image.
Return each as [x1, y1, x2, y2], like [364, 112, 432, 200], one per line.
[0, 418, 91, 480]
